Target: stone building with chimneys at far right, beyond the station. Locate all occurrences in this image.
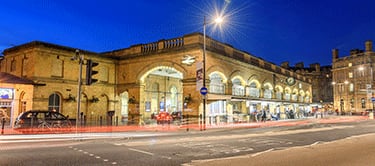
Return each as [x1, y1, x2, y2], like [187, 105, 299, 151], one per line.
[332, 41, 375, 114]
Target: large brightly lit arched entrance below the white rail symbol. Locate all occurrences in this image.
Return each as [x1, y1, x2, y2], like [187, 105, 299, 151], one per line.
[140, 66, 183, 123]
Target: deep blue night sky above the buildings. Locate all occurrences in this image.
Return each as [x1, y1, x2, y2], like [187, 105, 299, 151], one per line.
[0, 0, 375, 66]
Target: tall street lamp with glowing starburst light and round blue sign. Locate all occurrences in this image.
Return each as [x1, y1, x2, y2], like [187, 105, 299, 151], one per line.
[201, 16, 224, 130]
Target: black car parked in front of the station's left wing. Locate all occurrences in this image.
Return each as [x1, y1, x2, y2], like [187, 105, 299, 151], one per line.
[14, 110, 72, 129]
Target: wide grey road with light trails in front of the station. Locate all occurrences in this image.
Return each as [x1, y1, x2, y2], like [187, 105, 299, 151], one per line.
[0, 116, 375, 166]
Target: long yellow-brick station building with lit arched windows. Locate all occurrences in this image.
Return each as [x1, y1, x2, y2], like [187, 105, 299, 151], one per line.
[0, 33, 312, 125]
